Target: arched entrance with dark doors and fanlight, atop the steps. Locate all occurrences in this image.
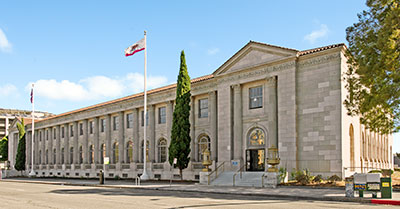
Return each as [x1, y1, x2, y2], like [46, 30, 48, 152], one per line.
[246, 128, 265, 171]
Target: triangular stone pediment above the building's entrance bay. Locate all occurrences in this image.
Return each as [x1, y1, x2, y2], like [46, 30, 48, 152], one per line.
[213, 41, 297, 76]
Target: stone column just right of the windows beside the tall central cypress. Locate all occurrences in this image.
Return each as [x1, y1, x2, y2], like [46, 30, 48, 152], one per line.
[208, 91, 218, 161]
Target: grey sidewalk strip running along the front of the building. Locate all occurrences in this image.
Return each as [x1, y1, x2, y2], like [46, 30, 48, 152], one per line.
[2, 178, 400, 205]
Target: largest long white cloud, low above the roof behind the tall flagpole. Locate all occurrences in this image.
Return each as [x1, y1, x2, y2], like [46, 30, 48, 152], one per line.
[26, 73, 167, 101]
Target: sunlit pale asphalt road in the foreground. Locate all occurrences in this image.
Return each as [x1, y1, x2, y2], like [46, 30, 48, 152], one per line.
[0, 181, 395, 209]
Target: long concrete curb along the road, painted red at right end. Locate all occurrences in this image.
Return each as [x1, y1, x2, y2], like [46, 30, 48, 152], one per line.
[2, 179, 388, 205]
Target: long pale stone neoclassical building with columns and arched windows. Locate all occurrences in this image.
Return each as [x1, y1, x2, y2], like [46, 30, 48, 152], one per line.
[9, 41, 393, 180]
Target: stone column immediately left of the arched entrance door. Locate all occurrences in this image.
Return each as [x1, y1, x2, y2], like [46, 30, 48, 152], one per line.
[233, 84, 243, 161]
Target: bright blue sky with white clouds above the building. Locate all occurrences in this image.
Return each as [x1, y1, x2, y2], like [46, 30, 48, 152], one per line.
[0, 0, 400, 152]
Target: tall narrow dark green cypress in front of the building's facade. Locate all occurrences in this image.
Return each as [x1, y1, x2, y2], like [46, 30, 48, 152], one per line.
[168, 50, 191, 180]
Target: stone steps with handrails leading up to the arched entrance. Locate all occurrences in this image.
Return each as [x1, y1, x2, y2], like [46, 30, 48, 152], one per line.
[210, 171, 264, 187]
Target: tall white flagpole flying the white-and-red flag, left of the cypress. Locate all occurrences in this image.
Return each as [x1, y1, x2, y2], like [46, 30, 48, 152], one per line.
[140, 31, 149, 180]
